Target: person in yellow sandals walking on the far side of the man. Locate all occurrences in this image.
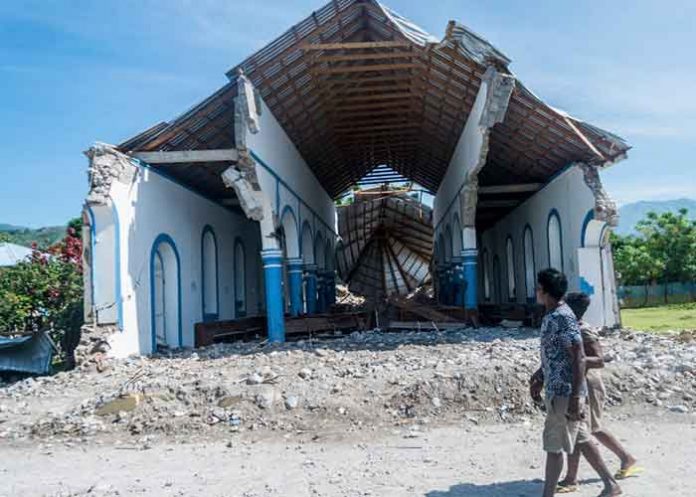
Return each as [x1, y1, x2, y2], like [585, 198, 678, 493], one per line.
[557, 292, 642, 493]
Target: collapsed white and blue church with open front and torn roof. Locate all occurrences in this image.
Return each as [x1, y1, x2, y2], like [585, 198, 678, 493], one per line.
[83, 0, 630, 355]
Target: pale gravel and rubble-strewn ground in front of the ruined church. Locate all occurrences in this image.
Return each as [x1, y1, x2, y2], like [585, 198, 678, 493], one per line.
[0, 328, 696, 497]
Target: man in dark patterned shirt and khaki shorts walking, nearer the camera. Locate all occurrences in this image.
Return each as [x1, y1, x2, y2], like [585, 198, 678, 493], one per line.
[530, 269, 622, 497]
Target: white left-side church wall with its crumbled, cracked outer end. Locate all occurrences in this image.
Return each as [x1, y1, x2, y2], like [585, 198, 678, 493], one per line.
[85, 144, 262, 356]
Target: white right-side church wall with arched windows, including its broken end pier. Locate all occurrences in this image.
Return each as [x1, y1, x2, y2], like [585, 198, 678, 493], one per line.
[479, 165, 618, 326]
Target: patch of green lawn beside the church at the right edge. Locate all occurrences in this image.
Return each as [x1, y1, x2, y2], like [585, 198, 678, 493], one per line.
[621, 303, 696, 331]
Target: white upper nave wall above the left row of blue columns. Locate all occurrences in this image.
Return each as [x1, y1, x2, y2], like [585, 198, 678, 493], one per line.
[247, 98, 337, 236]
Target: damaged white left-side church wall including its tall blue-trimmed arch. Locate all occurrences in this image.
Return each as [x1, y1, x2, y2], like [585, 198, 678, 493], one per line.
[87, 145, 262, 356]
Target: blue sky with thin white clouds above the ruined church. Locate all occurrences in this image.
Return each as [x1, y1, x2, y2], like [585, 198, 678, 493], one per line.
[0, 0, 696, 227]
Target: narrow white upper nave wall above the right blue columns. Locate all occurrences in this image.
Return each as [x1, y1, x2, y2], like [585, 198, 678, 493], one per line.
[433, 77, 488, 230]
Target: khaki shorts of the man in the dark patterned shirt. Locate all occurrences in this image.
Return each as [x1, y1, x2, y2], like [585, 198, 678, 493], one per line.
[544, 397, 590, 454]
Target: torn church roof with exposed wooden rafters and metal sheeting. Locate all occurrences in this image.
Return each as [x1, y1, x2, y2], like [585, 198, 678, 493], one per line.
[123, 0, 630, 203]
